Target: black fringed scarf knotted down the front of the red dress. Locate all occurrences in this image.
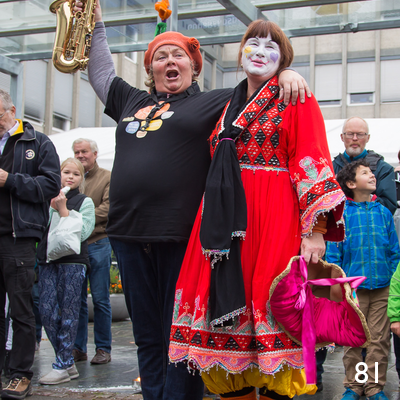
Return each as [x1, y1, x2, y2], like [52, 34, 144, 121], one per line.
[200, 79, 279, 327]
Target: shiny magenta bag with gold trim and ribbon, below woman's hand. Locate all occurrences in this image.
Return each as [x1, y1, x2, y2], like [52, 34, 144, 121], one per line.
[269, 256, 371, 384]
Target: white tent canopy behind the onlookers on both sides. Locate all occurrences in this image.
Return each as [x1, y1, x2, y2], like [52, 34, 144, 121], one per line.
[50, 118, 400, 170]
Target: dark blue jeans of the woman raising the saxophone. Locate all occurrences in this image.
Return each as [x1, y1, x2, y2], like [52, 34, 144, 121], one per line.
[110, 239, 204, 400]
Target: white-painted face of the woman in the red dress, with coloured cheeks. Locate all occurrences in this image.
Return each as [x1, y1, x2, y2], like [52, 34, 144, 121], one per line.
[242, 34, 281, 79]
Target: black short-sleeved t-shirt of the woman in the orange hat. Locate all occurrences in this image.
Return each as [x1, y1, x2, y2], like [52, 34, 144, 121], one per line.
[105, 78, 232, 242]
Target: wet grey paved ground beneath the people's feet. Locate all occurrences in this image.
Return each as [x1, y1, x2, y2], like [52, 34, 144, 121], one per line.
[3, 321, 400, 400]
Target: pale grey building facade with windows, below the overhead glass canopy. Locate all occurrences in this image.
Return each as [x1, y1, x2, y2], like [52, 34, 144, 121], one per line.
[0, 29, 400, 134]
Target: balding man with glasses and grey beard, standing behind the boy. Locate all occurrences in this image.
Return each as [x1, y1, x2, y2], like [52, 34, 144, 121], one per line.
[333, 117, 397, 214]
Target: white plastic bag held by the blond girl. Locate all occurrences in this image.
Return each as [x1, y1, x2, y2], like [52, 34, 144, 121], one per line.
[47, 210, 83, 262]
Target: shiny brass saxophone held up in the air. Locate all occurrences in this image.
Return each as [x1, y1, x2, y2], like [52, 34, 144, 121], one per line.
[50, 0, 96, 73]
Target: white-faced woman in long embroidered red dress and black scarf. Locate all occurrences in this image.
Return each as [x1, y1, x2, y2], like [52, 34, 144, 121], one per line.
[169, 20, 345, 400]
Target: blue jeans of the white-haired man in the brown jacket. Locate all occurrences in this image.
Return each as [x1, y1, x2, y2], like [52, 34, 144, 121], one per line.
[75, 238, 112, 353]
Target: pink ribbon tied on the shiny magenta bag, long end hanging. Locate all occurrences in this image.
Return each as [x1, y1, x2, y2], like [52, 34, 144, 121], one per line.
[294, 256, 367, 384]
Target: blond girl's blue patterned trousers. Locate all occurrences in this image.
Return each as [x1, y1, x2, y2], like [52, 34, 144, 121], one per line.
[39, 263, 86, 369]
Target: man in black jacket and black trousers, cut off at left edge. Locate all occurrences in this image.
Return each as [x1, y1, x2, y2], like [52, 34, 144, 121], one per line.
[0, 90, 61, 399]
